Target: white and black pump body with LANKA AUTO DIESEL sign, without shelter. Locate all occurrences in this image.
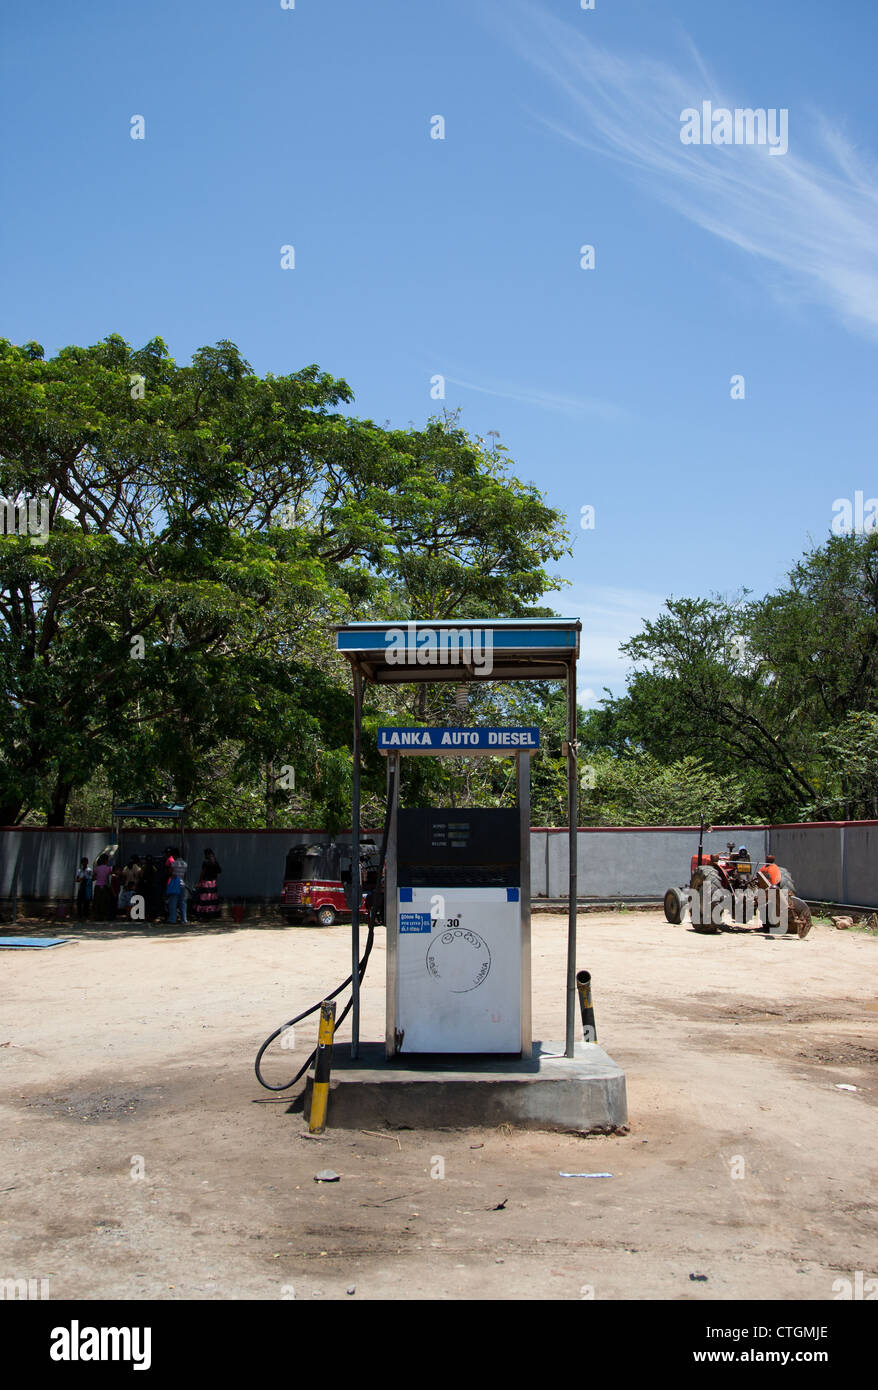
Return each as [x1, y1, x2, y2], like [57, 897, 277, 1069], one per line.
[378, 728, 539, 1058]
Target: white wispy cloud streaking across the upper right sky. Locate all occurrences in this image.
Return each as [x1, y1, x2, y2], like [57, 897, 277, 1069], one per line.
[502, 0, 878, 336]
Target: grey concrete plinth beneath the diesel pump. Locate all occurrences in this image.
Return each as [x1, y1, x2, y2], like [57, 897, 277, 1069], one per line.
[304, 1043, 628, 1134]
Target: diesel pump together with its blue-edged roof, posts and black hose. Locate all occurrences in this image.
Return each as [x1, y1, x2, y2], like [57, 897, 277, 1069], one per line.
[256, 617, 582, 1091]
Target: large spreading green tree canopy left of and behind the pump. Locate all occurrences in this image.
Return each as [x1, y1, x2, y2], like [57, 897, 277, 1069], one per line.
[0, 335, 568, 824]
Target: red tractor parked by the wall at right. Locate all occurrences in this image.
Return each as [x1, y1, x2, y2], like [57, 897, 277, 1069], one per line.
[664, 817, 811, 938]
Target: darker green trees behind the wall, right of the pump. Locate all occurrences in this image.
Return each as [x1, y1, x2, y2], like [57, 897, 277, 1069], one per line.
[583, 531, 878, 820]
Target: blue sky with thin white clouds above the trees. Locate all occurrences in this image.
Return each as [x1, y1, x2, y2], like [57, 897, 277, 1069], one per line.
[0, 0, 878, 703]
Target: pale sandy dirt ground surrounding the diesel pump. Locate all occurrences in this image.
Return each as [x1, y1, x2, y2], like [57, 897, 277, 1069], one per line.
[0, 912, 878, 1300]
